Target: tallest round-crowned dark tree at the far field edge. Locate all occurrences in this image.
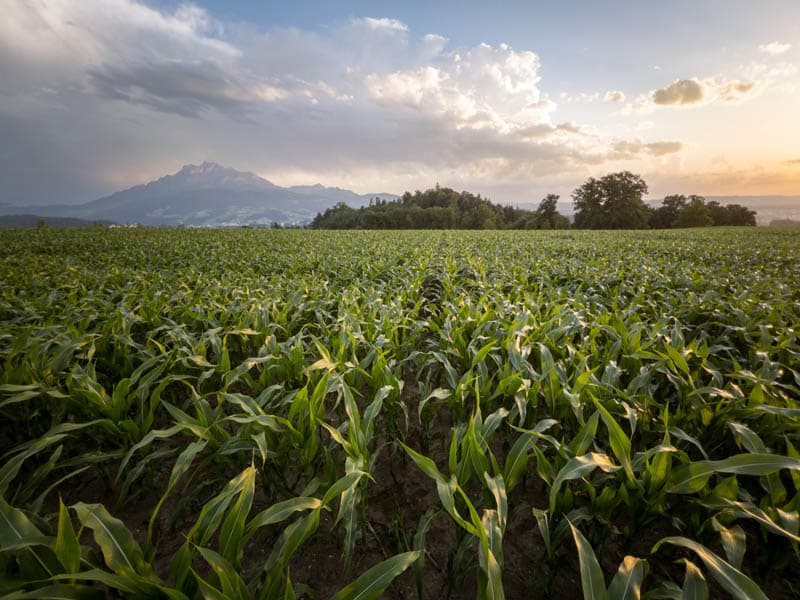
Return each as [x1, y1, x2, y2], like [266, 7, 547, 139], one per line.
[572, 171, 650, 229]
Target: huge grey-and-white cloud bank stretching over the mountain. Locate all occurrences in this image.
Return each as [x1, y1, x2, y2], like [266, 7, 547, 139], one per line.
[0, 0, 688, 202]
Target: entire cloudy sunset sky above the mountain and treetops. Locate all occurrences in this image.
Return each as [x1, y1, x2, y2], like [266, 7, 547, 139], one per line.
[0, 0, 800, 205]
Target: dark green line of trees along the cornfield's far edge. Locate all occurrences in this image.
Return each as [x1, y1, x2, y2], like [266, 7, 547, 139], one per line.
[309, 171, 756, 229]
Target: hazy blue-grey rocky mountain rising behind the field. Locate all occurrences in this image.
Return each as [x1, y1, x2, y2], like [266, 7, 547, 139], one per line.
[0, 162, 397, 227]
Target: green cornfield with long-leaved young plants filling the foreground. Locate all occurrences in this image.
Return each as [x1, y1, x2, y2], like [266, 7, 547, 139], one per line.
[0, 228, 800, 600]
